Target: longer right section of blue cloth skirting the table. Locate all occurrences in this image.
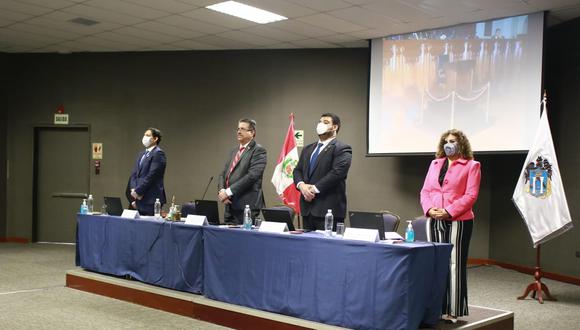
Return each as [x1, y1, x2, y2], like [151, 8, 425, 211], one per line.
[204, 227, 451, 329]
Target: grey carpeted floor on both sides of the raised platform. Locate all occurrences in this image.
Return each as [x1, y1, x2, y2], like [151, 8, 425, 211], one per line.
[0, 243, 580, 330]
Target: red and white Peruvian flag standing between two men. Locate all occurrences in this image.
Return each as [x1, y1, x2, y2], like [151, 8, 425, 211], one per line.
[272, 113, 300, 214]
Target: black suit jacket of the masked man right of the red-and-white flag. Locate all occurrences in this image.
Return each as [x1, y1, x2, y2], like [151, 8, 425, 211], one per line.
[294, 139, 352, 218]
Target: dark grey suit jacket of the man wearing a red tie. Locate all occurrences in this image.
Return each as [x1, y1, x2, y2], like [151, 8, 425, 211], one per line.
[218, 140, 267, 210]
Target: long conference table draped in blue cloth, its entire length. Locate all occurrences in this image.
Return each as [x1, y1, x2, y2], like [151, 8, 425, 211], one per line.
[77, 215, 452, 329]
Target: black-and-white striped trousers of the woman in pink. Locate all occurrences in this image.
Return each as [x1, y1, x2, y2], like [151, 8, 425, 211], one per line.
[427, 219, 473, 317]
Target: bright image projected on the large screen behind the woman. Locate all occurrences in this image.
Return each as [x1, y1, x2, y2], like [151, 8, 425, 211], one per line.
[369, 14, 543, 154]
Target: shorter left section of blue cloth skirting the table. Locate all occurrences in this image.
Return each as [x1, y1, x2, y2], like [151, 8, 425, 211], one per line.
[77, 215, 203, 293]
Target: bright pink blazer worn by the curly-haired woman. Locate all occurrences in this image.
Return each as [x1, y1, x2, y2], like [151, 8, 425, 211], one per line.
[421, 158, 481, 220]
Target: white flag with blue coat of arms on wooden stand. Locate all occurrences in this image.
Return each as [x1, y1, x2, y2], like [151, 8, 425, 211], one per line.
[512, 95, 574, 248]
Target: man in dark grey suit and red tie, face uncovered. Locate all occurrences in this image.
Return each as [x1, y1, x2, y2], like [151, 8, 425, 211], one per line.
[218, 118, 267, 224]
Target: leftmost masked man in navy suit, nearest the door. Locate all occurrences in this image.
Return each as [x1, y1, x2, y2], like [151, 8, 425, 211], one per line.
[129, 127, 167, 215]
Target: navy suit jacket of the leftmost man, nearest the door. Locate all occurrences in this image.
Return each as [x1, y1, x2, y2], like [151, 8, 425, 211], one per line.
[129, 147, 167, 207]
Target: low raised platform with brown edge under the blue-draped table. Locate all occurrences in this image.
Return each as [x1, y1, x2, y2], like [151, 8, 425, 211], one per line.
[66, 268, 514, 330]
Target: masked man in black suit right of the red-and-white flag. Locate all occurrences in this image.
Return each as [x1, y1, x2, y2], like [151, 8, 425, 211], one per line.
[294, 113, 352, 230]
